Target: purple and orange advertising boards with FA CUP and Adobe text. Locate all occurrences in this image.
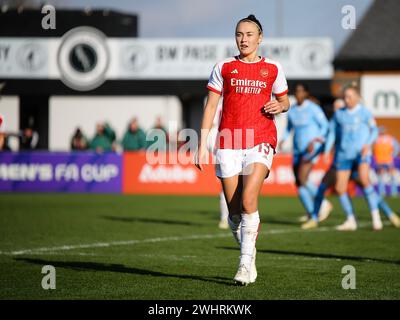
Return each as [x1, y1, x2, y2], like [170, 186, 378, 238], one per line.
[0, 151, 400, 195]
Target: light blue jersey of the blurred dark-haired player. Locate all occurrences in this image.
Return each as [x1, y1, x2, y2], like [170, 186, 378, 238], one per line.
[283, 100, 329, 156]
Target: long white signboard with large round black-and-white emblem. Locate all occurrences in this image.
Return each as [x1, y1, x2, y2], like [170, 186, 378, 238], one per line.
[0, 34, 334, 91]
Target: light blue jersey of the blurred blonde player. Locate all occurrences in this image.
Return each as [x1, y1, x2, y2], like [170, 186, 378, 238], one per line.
[326, 104, 378, 168]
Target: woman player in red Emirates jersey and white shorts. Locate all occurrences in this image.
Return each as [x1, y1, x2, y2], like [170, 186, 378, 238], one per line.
[195, 15, 290, 285]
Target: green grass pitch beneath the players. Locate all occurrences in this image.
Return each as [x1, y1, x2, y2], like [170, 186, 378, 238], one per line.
[0, 194, 400, 300]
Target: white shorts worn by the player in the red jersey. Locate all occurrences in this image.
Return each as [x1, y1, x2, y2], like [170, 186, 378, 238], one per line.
[215, 143, 274, 178]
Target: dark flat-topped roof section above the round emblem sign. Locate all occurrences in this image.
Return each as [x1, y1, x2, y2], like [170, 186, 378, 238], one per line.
[0, 9, 138, 37]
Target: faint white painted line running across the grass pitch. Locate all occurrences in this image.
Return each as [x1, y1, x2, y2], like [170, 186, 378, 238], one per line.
[0, 221, 382, 256]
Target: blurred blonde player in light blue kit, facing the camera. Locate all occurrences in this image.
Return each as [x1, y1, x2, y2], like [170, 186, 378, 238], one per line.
[327, 86, 383, 231]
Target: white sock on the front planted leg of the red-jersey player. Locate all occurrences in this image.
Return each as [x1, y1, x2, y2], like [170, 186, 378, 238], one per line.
[240, 211, 260, 268]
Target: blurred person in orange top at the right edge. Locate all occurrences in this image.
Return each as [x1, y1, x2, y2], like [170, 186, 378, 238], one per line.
[373, 127, 400, 197]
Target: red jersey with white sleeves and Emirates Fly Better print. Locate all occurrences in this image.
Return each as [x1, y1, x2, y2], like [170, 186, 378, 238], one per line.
[207, 57, 288, 149]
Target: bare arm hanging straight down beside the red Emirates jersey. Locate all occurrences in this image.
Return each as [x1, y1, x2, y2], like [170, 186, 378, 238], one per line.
[195, 90, 221, 170]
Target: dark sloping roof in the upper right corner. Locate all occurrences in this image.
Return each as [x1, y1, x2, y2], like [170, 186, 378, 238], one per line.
[333, 0, 400, 71]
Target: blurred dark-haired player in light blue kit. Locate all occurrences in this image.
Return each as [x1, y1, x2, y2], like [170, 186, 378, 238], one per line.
[281, 83, 331, 229]
